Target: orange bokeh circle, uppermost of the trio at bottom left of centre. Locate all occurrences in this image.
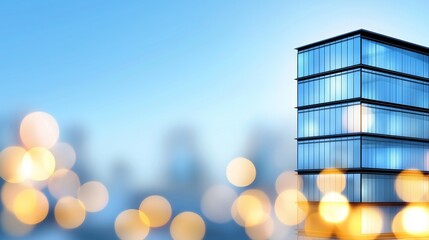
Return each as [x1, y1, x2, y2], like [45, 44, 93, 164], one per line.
[139, 195, 172, 228]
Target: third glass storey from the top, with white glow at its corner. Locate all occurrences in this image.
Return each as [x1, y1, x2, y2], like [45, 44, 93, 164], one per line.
[298, 103, 429, 139]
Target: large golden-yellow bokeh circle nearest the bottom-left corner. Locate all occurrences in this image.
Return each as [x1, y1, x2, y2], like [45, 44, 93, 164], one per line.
[13, 189, 49, 225]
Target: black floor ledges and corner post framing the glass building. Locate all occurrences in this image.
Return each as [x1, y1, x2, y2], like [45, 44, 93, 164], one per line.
[295, 29, 429, 237]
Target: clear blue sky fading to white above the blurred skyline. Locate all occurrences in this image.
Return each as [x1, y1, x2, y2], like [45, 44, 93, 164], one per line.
[0, 0, 429, 185]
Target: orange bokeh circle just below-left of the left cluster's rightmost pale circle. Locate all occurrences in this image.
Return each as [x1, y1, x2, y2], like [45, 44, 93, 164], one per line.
[55, 197, 86, 229]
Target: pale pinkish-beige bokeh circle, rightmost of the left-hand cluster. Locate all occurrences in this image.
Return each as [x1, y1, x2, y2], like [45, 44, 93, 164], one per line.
[78, 181, 109, 212]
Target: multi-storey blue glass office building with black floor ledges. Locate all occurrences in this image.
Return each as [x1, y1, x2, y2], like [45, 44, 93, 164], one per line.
[297, 30, 429, 239]
